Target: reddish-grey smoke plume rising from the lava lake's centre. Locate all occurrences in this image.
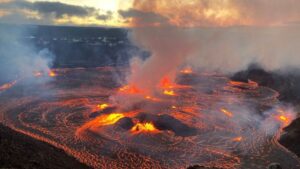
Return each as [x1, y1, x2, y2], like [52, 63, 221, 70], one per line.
[129, 27, 194, 91]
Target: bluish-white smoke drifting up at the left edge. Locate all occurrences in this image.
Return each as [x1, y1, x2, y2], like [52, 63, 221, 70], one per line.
[0, 25, 54, 83]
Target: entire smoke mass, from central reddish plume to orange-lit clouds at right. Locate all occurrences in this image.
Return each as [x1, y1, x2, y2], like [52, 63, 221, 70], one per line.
[119, 0, 300, 93]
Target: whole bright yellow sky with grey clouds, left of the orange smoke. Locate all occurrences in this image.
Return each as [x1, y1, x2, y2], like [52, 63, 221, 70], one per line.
[0, 0, 133, 27]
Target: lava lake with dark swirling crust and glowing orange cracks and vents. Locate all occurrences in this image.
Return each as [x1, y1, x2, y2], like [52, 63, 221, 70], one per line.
[0, 67, 300, 169]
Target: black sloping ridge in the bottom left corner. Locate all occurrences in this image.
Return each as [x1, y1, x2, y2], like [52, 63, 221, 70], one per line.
[0, 124, 89, 169]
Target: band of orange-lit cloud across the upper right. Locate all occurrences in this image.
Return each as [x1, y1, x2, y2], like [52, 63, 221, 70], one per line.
[128, 0, 300, 27]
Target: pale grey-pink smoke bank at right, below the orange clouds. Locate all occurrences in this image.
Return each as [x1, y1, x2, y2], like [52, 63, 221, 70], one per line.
[189, 26, 300, 73]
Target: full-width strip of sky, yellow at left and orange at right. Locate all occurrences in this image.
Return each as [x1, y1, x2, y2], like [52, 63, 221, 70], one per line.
[0, 0, 300, 27]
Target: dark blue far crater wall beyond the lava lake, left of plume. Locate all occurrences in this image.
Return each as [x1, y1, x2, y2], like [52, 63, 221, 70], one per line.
[0, 24, 149, 68]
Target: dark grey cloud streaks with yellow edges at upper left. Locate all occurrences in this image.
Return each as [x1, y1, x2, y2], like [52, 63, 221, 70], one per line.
[0, 0, 113, 25]
